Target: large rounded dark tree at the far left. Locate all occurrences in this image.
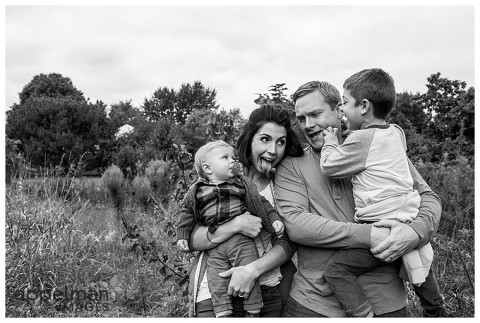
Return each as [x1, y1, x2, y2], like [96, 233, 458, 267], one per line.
[6, 74, 113, 167]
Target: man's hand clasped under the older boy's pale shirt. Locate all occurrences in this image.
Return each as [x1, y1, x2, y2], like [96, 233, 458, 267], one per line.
[370, 220, 420, 262]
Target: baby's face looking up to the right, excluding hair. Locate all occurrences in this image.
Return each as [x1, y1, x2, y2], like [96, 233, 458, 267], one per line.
[204, 147, 236, 183]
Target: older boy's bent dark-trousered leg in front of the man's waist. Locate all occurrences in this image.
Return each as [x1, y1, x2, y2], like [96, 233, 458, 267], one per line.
[323, 249, 382, 317]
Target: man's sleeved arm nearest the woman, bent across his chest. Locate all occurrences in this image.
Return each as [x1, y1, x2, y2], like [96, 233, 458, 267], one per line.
[275, 158, 371, 248]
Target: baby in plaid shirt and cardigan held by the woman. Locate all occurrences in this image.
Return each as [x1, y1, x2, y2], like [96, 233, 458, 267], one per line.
[177, 140, 284, 317]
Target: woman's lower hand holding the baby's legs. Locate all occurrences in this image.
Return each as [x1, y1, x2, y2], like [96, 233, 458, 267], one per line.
[219, 263, 258, 298]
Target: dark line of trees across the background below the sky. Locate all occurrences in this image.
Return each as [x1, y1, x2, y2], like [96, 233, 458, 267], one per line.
[6, 73, 475, 177]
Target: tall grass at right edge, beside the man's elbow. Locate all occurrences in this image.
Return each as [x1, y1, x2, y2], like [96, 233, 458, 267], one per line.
[408, 158, 475, 317]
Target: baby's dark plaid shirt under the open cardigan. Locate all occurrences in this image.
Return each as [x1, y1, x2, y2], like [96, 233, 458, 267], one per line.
[196, 179, 247, 232]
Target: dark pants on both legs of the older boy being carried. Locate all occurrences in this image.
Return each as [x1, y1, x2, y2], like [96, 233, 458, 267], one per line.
[323, 249, 443, 317]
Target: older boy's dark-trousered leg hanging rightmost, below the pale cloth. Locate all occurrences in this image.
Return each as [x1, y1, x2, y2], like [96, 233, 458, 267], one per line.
[412, 269, 445, 317]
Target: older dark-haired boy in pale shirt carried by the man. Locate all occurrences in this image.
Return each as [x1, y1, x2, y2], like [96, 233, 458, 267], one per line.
[320, 69, 443, 317]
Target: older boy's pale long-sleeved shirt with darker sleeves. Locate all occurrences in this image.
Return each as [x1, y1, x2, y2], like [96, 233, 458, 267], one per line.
[320, 124, 420, 223]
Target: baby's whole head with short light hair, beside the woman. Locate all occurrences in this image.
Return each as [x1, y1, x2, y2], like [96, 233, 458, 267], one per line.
[195, 140, 238, 183]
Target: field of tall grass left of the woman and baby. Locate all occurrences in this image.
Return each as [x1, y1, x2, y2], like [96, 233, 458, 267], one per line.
[5, 166, 190, 317]
